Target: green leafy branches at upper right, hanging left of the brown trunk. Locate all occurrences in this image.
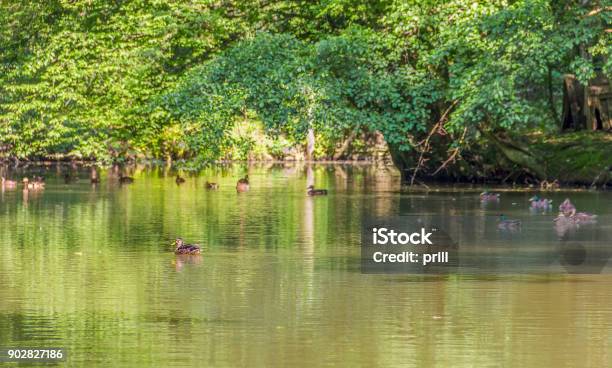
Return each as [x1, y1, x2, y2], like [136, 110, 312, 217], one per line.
[387, 0, 610, 137]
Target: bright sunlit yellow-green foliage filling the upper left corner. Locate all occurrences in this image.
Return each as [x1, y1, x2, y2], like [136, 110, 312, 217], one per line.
[0, 0, 249, 159]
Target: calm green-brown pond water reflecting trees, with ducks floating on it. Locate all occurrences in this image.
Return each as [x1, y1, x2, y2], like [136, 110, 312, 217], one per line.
[0, 165, 612, 367]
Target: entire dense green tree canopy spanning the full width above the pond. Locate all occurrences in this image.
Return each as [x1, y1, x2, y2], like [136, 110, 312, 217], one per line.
[0, 0, 612, 175]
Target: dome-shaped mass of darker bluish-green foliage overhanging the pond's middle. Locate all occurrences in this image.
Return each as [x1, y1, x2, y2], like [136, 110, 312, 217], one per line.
[158, 29, 437, 158]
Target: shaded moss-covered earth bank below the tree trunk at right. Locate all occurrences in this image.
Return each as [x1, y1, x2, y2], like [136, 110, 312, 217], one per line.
[391, 132, 612, 188]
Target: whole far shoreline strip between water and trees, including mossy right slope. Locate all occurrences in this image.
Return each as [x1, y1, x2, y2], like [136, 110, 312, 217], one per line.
[0, 132, 612, 190]
